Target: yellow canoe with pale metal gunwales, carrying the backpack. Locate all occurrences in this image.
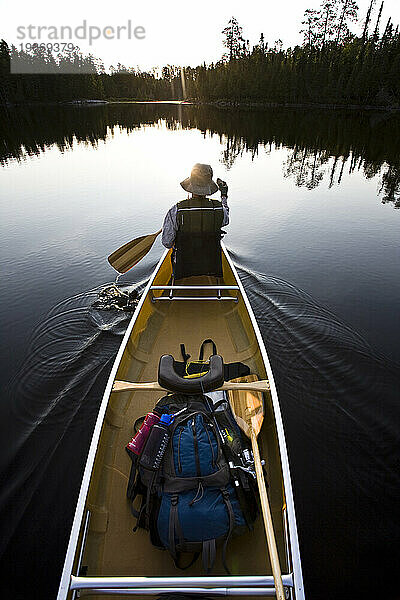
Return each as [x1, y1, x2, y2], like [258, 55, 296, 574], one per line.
[57, 245, 304, 600]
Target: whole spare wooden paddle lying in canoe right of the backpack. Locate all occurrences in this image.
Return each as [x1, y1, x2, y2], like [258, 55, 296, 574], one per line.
[228, 375, 285, 600]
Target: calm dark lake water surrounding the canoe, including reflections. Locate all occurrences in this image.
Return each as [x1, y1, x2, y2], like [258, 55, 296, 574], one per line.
[0, 104, 400, 600]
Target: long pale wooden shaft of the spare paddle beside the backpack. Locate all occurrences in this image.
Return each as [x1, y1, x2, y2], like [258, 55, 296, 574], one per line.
[250, 429, 285, 600]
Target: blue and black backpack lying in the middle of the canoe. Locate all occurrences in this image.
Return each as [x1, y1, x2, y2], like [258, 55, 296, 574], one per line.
[127, 394, 258, 573]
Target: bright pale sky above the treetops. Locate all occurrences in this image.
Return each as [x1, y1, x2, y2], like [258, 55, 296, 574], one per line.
[0, 0, 400, 69]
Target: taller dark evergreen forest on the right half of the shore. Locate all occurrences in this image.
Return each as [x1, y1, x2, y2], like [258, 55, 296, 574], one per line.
[187, 0, 400, 107]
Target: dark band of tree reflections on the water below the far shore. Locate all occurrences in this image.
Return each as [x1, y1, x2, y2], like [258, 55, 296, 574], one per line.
[0, 104, 400, 208]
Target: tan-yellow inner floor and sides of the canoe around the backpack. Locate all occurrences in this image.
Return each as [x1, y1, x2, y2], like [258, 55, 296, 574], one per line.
[74, 248, 288, 596]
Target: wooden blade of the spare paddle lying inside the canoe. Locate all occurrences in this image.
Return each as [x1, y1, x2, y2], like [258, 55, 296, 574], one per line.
[228, 375, 264, 437]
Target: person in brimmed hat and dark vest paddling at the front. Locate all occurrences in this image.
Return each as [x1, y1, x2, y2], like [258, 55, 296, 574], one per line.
[162, 163, 229, 279]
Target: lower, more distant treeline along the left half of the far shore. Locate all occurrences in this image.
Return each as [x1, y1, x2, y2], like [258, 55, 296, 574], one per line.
[0, 40, 182, 104]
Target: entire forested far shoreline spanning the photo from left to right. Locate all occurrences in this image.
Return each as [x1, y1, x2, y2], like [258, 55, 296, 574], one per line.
[0, 0, 400, 109]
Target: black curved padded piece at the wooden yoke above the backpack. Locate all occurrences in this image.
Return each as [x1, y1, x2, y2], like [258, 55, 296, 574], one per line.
[158, 354, 224, 394]
